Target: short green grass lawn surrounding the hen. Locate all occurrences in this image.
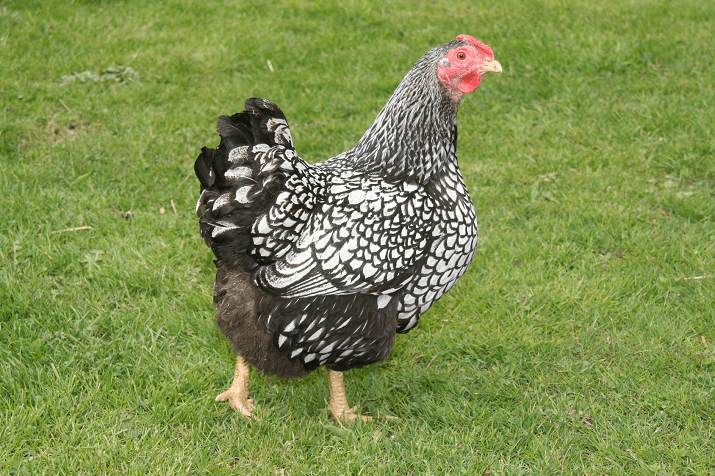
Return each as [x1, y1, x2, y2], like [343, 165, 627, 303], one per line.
[0, 0, 715, 475]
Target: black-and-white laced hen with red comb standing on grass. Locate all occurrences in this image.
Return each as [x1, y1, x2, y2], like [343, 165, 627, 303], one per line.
[195, 35, 502, 421]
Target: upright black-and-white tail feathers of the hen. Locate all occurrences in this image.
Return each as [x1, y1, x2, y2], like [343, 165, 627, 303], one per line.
[194, 98, 302, 263]
